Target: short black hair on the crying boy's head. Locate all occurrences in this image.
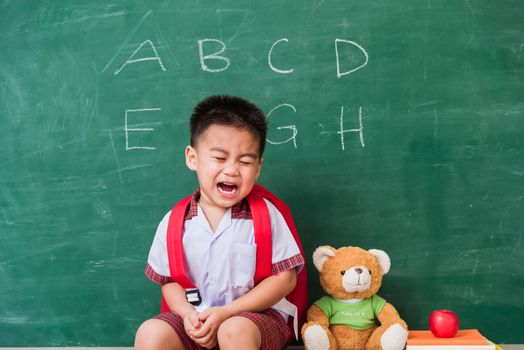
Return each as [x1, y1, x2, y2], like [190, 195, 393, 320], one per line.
[189, 95, 267, 156]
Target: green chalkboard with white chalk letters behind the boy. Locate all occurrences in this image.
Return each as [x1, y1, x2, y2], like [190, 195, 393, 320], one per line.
[0, 0, 524, 346]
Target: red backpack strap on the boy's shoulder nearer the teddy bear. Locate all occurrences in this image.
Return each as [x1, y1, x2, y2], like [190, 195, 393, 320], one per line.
[247, 188, 273, 284]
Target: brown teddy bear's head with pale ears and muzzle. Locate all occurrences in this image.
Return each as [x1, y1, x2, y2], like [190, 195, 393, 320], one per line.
[313, 246, 391, 300]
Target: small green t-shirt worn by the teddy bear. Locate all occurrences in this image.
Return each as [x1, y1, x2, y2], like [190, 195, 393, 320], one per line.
[315, 294, 386, 330]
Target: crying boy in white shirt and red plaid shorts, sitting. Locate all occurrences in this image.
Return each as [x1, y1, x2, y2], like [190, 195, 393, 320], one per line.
[135, 96, 304, 350]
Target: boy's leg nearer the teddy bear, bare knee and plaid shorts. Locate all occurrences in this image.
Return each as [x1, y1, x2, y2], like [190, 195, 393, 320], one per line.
[218, 309, 291, 350]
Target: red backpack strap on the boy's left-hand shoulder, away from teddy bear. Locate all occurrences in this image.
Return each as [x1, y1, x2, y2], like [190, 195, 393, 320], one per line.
[166, 196, 195, 289]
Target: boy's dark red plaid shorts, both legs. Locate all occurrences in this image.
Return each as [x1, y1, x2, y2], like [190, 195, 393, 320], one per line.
[155, 309, 291, 350]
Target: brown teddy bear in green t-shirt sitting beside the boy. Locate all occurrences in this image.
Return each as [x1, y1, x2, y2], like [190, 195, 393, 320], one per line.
[302, 246, 408, 350]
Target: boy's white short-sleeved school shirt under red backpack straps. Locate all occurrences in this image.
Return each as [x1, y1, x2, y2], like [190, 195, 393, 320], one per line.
[148, 199, 303, 320]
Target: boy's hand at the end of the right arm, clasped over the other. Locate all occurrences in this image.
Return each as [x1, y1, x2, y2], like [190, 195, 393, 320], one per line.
[189, 307, 231, 349]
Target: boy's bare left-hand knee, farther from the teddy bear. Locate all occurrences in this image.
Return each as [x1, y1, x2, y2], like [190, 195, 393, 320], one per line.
[135, 319, 183, 350]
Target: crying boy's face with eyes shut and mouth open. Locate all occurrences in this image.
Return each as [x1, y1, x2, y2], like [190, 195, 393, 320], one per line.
[186, 124, 262, 209]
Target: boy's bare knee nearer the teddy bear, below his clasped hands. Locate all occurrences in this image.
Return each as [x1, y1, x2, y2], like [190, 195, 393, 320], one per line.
[217, 316, 260, 348]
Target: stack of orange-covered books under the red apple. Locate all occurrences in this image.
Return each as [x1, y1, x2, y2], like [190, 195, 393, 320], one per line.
[406, 329, 500, 350]
